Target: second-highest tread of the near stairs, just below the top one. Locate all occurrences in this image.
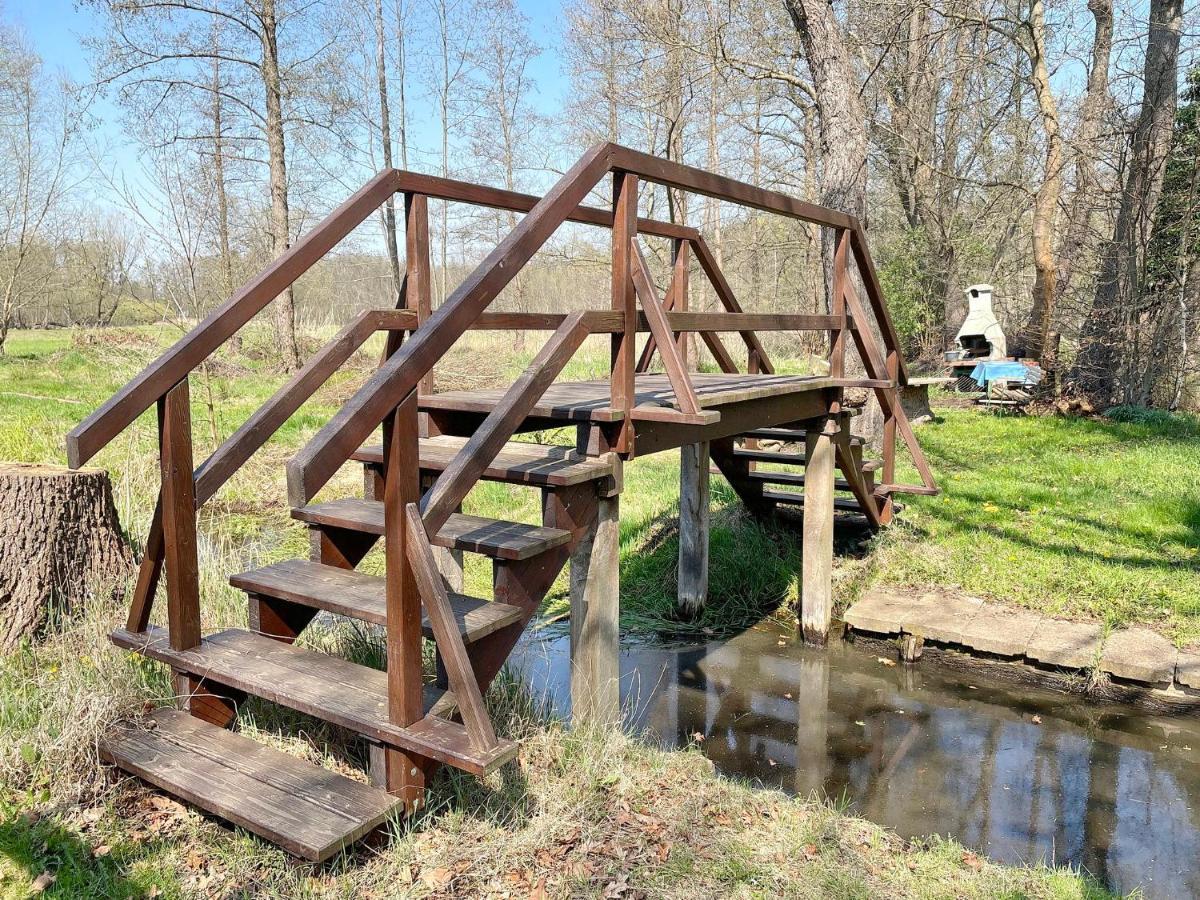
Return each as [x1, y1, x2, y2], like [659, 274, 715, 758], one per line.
[292, 497, 571, 559]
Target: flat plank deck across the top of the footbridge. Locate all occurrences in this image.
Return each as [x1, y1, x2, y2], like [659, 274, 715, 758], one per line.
[421, 373, 846, 422]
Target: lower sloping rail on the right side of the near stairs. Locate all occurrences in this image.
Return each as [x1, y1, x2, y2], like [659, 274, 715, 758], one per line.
[421, 312, 592, 534]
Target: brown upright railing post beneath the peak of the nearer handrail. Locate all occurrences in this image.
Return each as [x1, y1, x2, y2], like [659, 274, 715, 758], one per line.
[610, 172, 637, 455]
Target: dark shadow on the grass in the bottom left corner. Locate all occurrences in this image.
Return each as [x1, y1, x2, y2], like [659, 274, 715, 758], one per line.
[0, 814, 150, 898]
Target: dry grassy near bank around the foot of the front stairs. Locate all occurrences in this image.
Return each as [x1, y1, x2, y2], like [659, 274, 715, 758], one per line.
[0, 592, 1106, 900]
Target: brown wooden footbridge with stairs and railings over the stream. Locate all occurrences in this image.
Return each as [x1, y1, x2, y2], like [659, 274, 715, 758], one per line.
[67, 144, 935, 859]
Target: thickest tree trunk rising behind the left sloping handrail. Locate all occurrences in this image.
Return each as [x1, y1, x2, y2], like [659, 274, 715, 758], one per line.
[262, 0, 300, 371]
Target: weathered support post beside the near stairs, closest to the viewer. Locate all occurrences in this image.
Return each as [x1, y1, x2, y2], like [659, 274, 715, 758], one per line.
[571, 494, 620, 725]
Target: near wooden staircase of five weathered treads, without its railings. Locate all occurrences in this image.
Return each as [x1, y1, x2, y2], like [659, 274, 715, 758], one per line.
[102, 438, 613, 862]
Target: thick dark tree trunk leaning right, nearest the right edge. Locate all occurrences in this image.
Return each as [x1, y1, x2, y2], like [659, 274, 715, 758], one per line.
[1072, 0, 1183, 407]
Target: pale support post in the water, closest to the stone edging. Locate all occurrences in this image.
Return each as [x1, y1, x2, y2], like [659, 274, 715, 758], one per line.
[800, 416, 838, 644]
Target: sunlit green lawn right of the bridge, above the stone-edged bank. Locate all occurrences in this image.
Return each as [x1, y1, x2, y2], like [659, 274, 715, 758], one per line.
[871, 398, 1200, 643]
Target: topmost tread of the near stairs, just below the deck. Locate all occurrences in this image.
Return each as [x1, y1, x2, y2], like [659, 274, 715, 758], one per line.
[350, 434, 613, 487]
